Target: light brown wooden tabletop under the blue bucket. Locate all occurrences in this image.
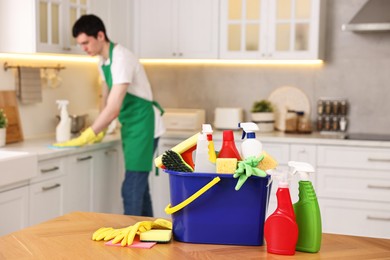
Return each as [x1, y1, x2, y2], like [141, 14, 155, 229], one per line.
[0, 212, 390, 260]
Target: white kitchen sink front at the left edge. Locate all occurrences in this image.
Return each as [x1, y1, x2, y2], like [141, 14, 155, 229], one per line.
[0, 150, 38, 187]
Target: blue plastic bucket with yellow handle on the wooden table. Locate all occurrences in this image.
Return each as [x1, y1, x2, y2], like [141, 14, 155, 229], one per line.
[165, 170, 271, 246]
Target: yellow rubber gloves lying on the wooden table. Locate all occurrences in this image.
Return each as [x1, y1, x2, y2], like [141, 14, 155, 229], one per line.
[92, 218, 172, 246]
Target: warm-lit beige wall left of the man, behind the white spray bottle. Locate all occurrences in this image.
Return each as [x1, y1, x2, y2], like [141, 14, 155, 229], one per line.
[0, 58, 100, 140]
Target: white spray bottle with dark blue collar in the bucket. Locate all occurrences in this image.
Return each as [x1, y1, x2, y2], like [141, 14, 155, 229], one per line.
[238, 122, 263, 159]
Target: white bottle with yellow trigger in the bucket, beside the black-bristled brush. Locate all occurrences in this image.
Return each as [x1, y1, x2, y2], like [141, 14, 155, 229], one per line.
[195, 124, 216, 173]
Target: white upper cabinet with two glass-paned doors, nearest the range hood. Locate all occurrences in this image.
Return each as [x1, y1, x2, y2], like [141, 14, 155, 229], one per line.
[220, 0, 325, 59]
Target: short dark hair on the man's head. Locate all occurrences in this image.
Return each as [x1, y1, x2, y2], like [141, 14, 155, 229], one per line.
[72, 14, 109, 42]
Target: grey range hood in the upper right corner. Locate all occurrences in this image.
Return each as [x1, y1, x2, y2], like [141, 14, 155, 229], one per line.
[341, 0, 390, 32]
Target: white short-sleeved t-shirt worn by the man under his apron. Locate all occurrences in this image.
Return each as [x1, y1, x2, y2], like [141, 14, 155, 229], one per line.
[98, 44, 165, 138]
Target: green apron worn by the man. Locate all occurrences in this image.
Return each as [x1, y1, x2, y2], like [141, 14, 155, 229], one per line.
[102, 42, 163, 172]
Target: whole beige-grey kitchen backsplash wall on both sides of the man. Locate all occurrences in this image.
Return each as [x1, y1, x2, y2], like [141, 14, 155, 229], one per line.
[0, 0, 390, 138]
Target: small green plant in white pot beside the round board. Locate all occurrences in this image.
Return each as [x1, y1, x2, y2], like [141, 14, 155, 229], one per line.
[251, 99, 275, 132]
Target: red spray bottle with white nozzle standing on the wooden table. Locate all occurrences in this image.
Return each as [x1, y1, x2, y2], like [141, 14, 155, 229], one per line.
[264, 169, 298, 255]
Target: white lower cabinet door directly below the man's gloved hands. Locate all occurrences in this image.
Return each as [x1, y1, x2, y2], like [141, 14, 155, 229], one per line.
[64, 152, 96, 213]
